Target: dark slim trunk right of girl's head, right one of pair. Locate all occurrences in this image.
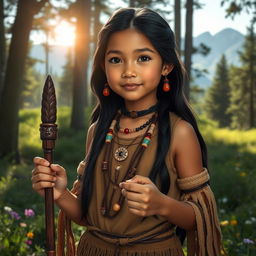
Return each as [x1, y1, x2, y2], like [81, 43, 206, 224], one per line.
[184, 0, 193, 100]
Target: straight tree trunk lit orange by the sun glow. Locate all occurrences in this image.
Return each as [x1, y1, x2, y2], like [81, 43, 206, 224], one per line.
[70, 0, 91, 129]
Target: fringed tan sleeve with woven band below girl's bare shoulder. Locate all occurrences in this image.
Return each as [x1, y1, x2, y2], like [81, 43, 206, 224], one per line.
[177, 168, 222, 256]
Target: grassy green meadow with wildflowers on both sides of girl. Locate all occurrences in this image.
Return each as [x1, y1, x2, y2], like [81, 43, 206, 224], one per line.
[0, 107, 256, 256]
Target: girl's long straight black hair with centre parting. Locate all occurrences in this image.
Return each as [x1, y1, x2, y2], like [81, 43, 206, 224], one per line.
[81, 8, 208, 242]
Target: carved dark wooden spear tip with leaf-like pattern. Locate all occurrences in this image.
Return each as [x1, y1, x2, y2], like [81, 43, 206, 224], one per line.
[41, 75, 57, 124]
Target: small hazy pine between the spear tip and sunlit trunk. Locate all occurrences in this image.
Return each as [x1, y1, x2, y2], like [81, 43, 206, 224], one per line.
[58, 48, 74, 107]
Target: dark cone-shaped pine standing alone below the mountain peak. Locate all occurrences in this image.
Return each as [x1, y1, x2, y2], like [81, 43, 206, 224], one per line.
[205, 55, 231, 127]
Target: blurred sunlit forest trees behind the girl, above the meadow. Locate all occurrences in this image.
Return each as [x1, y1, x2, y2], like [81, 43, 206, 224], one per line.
[0, 0, 256, 161]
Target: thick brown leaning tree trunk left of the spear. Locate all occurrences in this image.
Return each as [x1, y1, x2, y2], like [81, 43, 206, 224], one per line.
[0, 0, 46, 162]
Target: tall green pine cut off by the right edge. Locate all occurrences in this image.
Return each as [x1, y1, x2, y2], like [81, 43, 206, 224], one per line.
[228, 22, 256, 129]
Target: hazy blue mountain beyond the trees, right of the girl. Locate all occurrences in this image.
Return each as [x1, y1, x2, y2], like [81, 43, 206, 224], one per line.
[192, 28, 244, 88]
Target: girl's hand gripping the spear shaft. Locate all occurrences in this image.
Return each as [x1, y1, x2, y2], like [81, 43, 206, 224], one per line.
[31, 157, 67, 200]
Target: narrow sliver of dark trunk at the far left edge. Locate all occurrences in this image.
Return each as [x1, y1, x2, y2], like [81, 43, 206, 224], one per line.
[0, 0, 6, 101]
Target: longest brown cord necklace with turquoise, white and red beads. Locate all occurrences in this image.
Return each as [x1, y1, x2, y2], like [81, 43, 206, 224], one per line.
[101, 112, 157, 218]
